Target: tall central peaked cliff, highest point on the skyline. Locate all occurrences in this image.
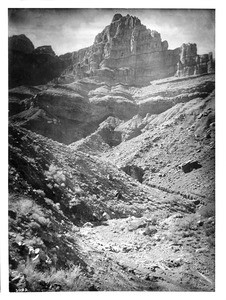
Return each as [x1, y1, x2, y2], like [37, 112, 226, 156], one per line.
[57, 14, 180, 85]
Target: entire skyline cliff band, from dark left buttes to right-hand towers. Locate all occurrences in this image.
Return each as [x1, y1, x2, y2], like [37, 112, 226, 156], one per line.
[9, 14, 214, 87]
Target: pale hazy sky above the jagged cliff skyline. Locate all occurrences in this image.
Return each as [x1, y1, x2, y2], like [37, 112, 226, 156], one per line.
[9, 9, 215, 55]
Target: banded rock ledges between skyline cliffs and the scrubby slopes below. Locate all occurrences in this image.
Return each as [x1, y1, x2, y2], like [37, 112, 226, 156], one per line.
[9, 75, 215, 144]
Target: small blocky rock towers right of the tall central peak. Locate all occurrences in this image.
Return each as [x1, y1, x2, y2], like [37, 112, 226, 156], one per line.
[176, 43, 215, 77]
